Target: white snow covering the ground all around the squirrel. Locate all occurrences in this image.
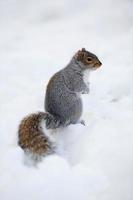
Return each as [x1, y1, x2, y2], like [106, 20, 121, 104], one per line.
[0, 0, 133, 200]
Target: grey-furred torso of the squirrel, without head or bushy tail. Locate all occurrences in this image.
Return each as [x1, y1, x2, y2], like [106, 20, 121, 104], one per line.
[45, 58, 89, 128]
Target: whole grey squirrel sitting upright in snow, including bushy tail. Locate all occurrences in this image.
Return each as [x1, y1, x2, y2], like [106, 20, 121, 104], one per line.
[18, 48, 102, 160]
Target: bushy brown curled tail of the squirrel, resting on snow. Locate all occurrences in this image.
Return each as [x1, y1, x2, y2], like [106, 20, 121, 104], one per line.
[18, 112, 55, 159]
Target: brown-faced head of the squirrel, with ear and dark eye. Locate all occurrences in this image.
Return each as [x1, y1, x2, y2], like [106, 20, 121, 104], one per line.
[74, 48, 102, 70]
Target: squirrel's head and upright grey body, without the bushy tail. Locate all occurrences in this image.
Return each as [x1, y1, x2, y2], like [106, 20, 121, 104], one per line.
[45, 48, 102, 129]
